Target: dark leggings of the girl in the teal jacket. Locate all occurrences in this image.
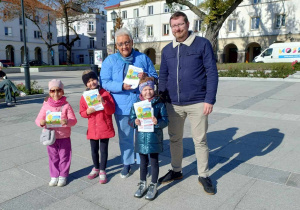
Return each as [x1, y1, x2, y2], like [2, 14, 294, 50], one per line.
[139, 153, 159, 183]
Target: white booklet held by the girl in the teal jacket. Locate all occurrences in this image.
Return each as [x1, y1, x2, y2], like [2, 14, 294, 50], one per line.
[133, 100, 154, 132]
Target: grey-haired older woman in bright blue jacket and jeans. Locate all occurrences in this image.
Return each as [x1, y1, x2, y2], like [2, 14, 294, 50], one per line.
[100, 28, 157, 178]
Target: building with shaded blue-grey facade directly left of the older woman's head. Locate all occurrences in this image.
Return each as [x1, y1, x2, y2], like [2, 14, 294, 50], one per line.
[56, 9, 107, 64]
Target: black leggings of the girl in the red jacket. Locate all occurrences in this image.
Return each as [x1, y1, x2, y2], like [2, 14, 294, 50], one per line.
[90, 139, 109, 170]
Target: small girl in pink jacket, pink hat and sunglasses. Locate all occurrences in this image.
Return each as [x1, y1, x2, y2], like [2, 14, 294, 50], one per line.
[35, 79, 77, 187]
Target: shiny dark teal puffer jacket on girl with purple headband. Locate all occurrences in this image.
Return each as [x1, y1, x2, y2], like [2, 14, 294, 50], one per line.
[128, 97, 169, 154]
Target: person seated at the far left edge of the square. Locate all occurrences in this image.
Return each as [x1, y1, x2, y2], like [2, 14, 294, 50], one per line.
[0, 62, 26, 106]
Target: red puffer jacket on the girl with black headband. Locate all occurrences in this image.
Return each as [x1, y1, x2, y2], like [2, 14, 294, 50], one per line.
[79, 89, 115, 140]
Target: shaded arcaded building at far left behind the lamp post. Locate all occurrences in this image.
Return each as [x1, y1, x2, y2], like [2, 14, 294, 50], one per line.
[0, 1, 58, 66]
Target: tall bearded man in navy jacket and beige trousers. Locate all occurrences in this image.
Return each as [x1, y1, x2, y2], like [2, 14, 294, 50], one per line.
[159, 12, 218, 194]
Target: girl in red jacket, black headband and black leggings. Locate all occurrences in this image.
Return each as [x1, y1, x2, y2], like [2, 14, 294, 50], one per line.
[79, 70, 115, 184]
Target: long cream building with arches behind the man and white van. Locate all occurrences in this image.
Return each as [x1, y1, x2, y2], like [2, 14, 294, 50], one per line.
[105, 0, 300, 64]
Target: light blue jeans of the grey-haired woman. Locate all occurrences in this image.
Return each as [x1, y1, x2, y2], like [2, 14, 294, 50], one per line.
[115, 114, 140, 165]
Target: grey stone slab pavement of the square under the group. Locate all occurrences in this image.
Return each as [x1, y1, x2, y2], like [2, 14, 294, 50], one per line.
[0, 71, 300, 210]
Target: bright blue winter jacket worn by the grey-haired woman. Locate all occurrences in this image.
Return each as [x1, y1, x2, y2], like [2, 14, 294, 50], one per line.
[100, 51, 158, 115]
